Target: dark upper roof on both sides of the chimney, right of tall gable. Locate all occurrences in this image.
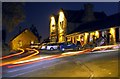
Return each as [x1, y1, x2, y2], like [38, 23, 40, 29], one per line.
[62, 9, 106, 23]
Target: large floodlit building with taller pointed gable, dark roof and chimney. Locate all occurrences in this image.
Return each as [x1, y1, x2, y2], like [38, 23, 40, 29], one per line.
[50, 4, 120, 46]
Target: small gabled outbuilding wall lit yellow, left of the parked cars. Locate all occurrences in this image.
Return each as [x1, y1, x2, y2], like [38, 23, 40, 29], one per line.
[10, 30, 38, 50]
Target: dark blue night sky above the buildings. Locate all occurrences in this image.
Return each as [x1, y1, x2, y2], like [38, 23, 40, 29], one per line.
[20, 2, 118, 39]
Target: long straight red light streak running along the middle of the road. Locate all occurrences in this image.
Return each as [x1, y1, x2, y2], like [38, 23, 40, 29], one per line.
[7, 49, 91, 68]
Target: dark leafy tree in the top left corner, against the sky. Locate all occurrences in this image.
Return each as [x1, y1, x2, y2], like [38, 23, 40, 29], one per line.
[2, 2, 25, 32]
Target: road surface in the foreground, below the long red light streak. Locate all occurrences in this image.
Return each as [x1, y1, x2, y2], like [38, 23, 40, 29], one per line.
[3, 50, 120, 77]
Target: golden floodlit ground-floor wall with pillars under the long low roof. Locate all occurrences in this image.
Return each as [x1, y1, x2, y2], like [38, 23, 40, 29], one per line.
[66, 27, 120, 46]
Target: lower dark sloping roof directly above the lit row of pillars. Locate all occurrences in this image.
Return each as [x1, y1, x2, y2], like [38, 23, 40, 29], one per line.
[70, 13, 120, 34]
